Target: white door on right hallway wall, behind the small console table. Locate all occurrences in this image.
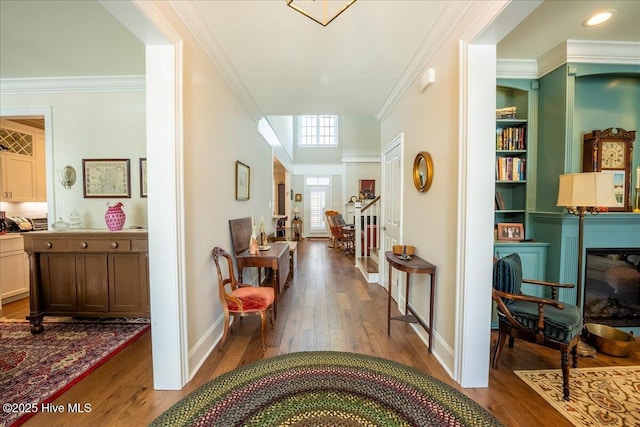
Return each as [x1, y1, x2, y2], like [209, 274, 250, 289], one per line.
[379, 134, 404, 301]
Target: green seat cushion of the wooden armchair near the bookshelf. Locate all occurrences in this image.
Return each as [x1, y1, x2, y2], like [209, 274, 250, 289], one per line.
[509, 301, 582, 343]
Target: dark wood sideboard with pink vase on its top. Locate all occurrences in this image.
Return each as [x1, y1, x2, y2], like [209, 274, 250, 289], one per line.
[24, 230, 150, 334]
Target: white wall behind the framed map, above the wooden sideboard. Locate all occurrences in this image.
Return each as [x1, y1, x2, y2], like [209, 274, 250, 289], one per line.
[0, 87, 147, 228]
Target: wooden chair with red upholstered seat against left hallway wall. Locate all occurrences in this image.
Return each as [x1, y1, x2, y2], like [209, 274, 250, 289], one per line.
[212, 247, 275, 352]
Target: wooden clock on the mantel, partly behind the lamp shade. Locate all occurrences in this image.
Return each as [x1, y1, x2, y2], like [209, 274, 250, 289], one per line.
[582, 128, 636, 211]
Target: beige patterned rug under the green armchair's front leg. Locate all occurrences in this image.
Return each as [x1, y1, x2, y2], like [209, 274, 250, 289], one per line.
[515, 366, 640, 427]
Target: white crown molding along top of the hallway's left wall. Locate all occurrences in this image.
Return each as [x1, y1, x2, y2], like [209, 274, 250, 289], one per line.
[169, 0, 264, 122]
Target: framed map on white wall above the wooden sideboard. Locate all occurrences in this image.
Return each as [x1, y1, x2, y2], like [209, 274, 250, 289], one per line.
[82, 159, 131, 198]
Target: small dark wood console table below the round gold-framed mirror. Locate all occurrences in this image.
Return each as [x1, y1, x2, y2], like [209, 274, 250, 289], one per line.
[385, 251, 436, 353]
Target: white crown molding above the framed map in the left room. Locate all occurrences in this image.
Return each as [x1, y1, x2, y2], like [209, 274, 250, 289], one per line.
[0, 76, 146, 95]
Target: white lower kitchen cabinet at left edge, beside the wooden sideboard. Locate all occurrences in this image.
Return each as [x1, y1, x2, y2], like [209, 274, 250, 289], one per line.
[0, 234, 29, 303]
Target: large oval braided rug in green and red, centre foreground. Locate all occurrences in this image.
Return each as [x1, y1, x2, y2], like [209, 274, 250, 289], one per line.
[151, 351, 501, 427]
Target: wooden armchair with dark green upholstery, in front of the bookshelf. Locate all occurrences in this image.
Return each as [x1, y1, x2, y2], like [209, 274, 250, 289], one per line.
[492, 254, 582, 400]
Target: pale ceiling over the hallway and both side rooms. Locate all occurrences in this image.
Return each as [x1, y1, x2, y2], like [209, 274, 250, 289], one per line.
[0, 0, 640, 115]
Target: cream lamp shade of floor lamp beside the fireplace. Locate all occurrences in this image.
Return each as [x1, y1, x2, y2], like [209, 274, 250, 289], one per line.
[556, 172, 617, 208]
